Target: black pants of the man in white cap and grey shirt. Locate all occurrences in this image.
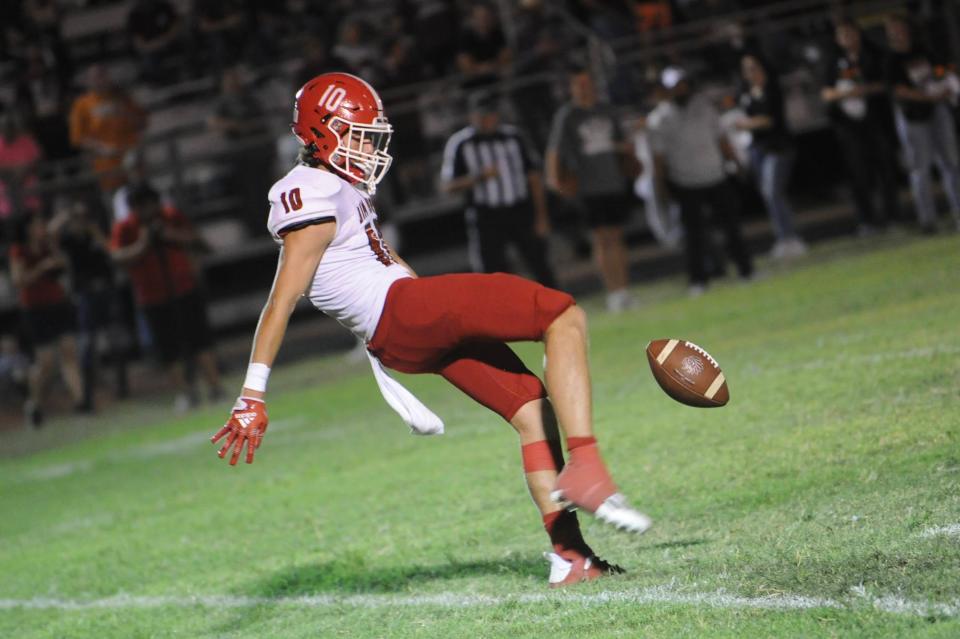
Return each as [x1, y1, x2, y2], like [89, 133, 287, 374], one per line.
[670, 180, 753, 285]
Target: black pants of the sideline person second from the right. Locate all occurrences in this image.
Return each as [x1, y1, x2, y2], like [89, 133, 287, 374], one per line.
[834, 120, 900, 225]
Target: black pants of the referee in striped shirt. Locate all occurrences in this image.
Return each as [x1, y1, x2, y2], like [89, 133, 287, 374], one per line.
[467, 202, 556, 288]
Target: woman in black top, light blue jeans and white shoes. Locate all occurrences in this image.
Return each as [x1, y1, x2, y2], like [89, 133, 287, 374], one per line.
[736, 53, 807, 259]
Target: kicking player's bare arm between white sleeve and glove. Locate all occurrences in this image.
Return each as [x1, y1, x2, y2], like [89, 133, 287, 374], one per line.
[243, 222, 337, 398]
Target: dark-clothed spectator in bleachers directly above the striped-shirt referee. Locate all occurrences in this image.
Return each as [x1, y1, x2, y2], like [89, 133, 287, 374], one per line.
[457, 2, 512, 87]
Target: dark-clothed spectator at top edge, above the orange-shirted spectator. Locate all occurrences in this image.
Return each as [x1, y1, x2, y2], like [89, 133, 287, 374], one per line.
[127, 0, 182, 83]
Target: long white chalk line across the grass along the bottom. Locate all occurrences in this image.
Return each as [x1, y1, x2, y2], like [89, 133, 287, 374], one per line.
[0, 586, 960, 617]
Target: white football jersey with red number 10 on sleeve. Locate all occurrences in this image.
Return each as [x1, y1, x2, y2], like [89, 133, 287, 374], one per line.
[267, 164, 410, 341]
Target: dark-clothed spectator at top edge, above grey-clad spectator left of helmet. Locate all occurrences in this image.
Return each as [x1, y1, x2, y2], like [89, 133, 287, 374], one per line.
[193, 0, 248, 73]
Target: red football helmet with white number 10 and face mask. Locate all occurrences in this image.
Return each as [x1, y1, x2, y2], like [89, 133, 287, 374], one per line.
[290, 73, 393, 195]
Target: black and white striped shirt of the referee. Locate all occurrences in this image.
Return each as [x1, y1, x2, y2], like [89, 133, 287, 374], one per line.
[440, 124, 540, 208]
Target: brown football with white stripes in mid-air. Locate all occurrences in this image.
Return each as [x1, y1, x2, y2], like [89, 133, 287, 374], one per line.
[647, 339, 730, 408]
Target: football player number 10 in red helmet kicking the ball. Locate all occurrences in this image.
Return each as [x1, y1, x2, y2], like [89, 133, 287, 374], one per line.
[211, 73, 650, 586]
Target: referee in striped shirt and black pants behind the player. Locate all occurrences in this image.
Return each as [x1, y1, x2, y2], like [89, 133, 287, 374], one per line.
[441, 94, 556, 288]
